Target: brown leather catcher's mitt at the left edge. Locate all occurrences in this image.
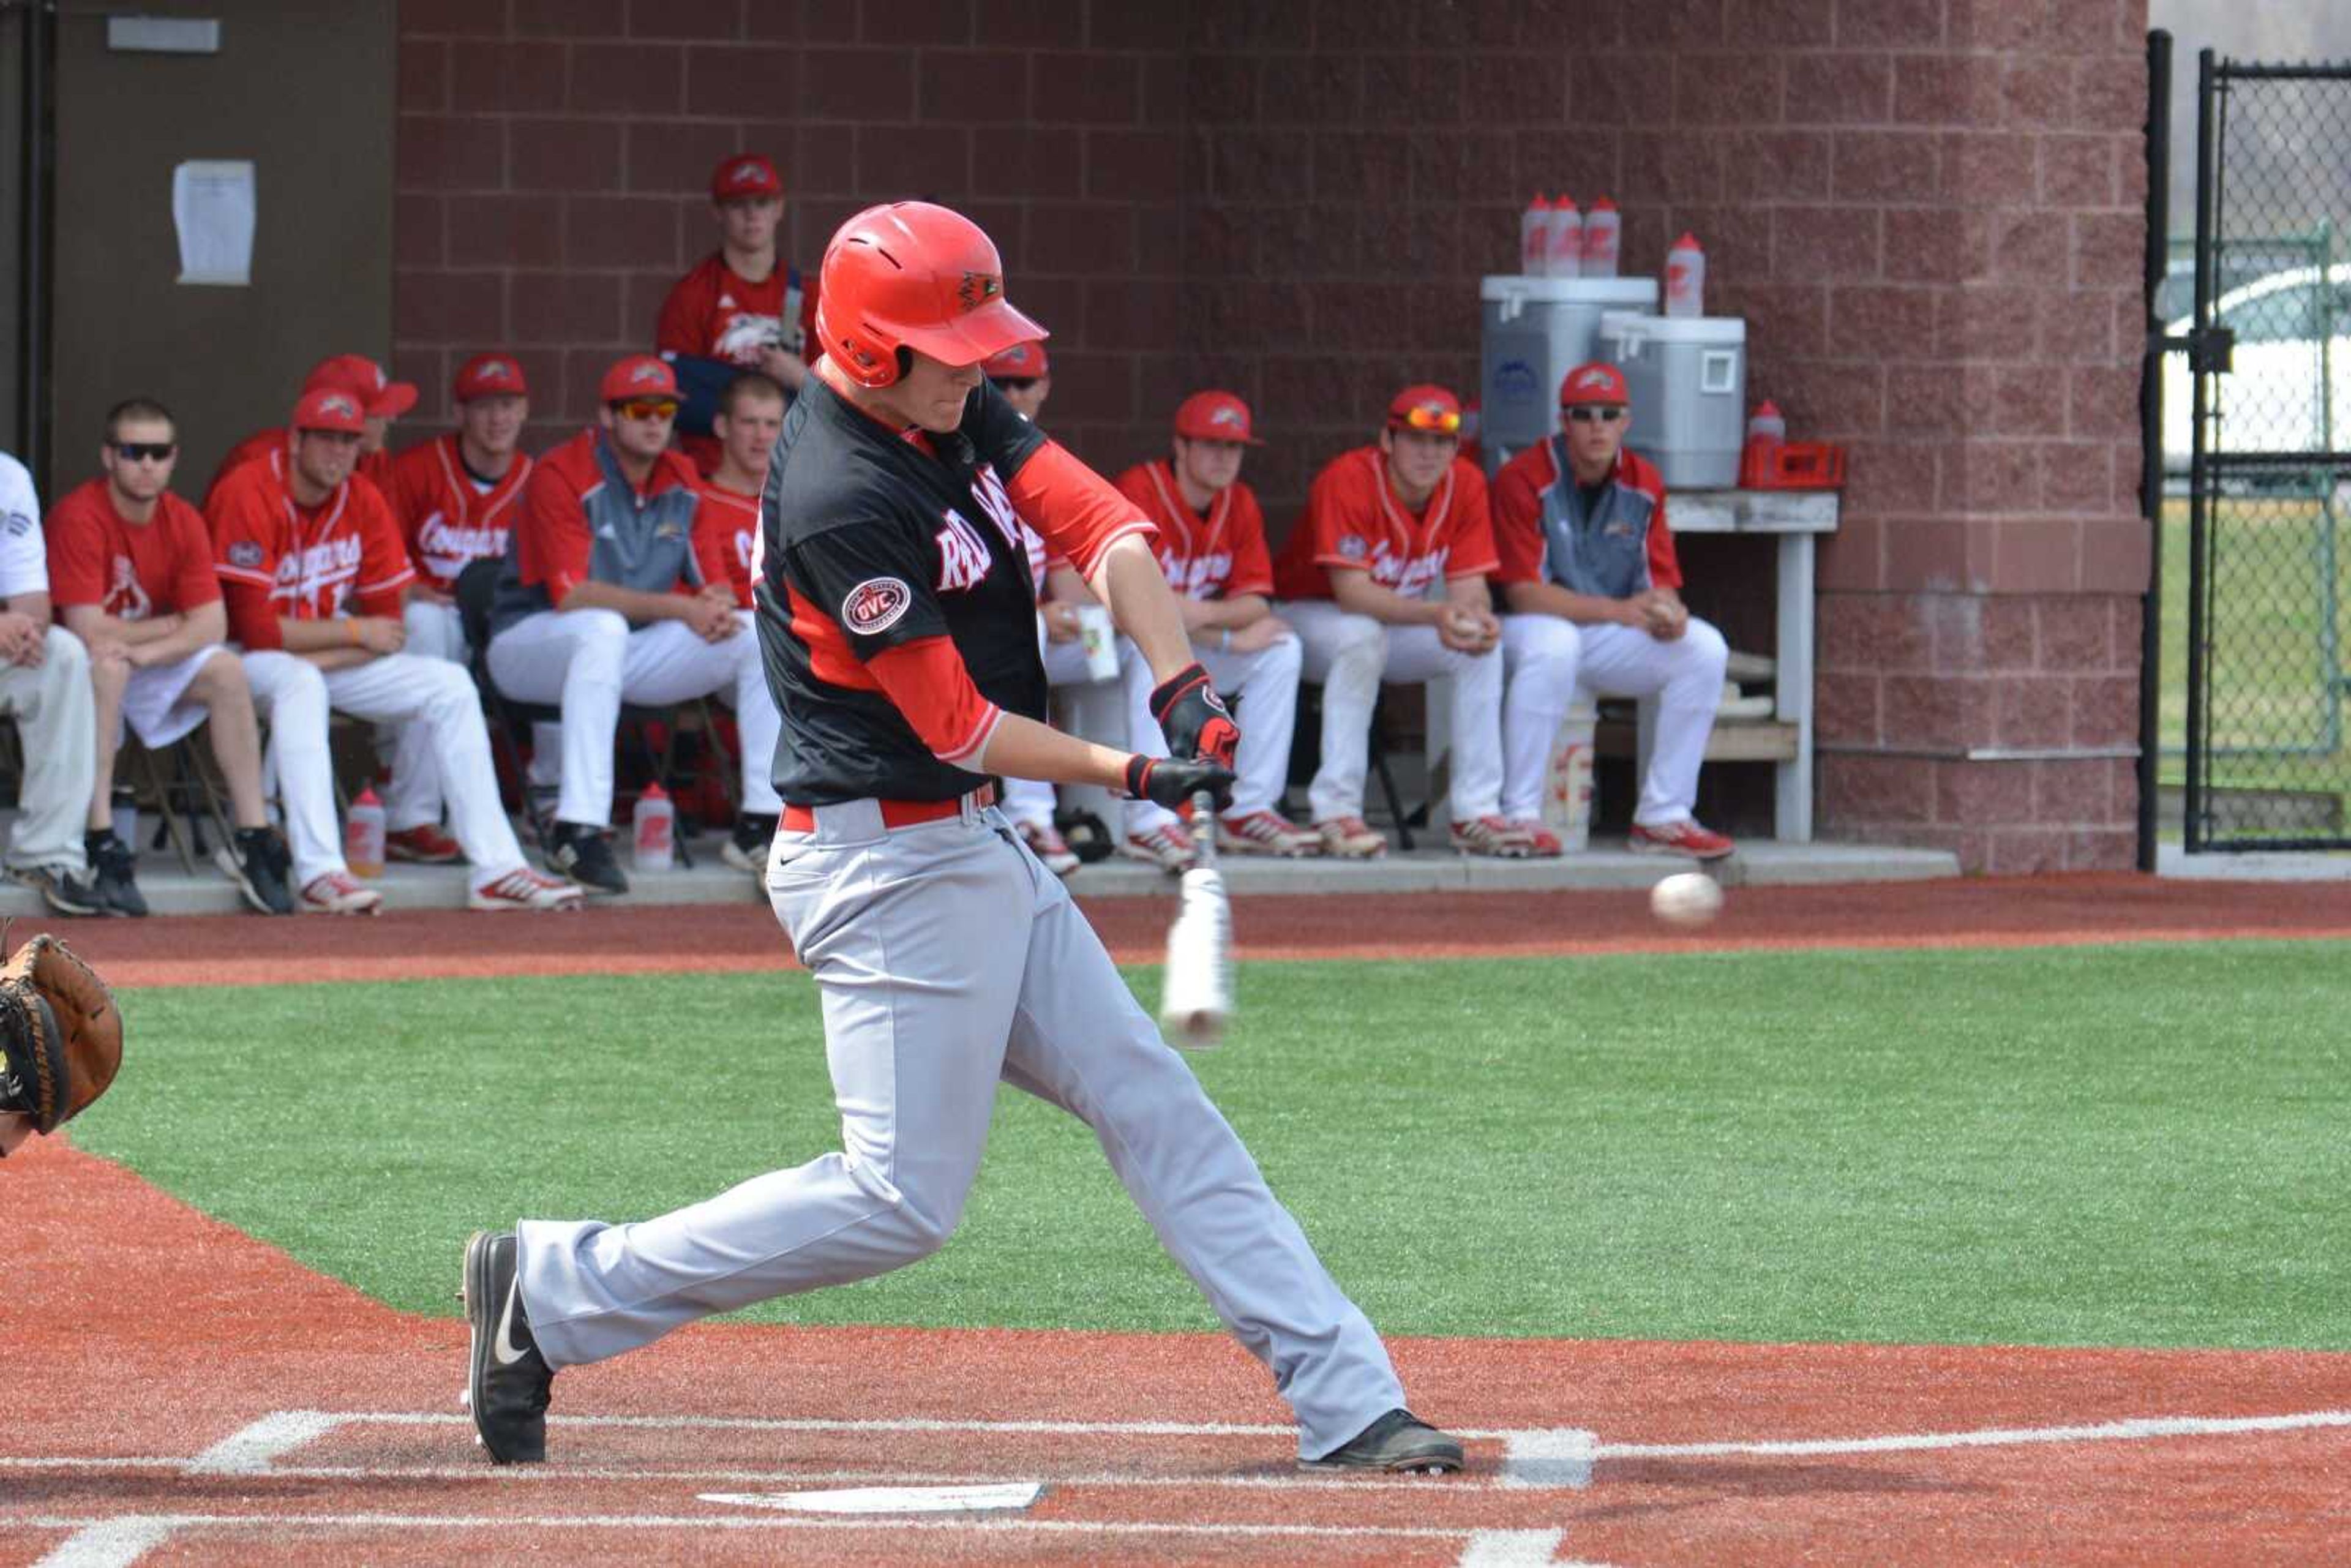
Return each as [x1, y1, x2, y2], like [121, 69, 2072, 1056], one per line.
[0, 933, 122, 1152]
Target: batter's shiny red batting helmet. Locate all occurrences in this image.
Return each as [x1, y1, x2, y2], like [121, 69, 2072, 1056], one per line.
[816, 202, 1046, 388]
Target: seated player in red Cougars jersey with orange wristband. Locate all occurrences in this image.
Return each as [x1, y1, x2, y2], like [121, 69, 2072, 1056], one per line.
[207, 392, 580, 915]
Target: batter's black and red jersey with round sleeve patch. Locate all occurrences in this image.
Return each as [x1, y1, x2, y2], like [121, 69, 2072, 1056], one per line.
[752, 373, 1152, 806]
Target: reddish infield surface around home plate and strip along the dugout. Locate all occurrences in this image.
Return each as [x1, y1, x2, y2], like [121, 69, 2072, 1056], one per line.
[0, 877, 2351, 1568]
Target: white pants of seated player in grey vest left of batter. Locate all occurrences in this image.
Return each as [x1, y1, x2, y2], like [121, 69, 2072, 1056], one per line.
[489, 609, 783, 828]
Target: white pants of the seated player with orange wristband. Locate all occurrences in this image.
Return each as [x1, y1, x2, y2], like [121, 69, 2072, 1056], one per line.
[244, 649, 524, 888]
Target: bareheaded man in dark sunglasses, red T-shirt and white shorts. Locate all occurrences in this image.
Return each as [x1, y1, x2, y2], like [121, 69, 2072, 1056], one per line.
[50, 397, 294, 915]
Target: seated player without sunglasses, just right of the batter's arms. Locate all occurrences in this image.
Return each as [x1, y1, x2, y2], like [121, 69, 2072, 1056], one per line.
[1119, 390, 1321, 856]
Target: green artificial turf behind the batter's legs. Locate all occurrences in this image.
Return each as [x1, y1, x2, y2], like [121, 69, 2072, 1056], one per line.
[75, 943, 2351, 1349]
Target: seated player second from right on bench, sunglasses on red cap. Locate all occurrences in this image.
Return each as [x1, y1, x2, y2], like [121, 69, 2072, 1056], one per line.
[1274, 386, 1537, 858]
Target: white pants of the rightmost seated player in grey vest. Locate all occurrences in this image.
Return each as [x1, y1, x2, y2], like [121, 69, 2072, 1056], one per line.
[1502, 616, 1730, 828]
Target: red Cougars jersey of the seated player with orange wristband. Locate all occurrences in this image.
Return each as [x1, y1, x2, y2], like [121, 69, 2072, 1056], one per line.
[212, 451, 416, 621]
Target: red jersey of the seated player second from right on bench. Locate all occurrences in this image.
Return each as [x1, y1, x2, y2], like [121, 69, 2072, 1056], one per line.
[1274, 447, 1498, 599]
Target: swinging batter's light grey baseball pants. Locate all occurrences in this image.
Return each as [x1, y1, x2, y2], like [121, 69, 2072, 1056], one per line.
[515, 797, 1403, 1458]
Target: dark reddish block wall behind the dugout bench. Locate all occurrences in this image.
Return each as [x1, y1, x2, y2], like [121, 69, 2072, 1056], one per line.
[395, 0, 2149, 870]
